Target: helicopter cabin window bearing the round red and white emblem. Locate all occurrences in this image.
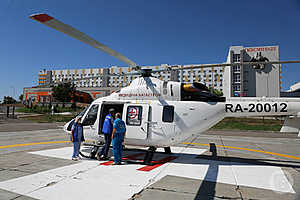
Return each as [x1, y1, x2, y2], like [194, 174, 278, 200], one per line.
[126, 106, 143, 126]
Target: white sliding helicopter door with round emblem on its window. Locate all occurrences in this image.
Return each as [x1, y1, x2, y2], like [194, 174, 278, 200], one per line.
[123, 104, 150, 140]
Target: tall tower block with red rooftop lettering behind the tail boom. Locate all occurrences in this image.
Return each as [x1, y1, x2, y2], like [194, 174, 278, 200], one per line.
[223, 46, 281, 97]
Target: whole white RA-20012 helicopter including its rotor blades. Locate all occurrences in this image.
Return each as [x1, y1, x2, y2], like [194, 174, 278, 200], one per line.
[30, 14, 300, 160]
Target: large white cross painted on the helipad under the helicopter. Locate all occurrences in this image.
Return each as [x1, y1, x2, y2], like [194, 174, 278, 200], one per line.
[0, 147, 295, 200]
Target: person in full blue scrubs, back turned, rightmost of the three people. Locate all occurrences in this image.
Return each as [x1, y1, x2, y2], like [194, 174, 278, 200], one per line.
[111, 113, 126, 165]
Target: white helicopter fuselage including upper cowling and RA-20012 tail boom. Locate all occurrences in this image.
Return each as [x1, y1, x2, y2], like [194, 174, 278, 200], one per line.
[65, 78, 300, 147]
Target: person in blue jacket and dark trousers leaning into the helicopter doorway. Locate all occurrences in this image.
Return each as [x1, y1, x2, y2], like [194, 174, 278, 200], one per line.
[97, 108, 115, 160]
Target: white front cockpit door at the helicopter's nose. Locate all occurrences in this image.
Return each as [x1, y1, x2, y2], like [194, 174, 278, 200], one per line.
[82, 104, 99, 140]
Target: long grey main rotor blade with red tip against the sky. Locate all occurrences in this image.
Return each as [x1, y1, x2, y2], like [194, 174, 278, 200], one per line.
[30, 14, 136, 67]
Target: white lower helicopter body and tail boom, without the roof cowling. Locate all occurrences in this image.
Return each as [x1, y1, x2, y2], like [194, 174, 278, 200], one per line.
[65, 98, 300, 147]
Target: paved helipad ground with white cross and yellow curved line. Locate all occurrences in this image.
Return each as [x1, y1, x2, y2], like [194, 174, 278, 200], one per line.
[0, 129, 300, 200]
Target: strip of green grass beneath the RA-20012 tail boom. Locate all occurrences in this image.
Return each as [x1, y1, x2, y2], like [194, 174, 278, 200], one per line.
[212, 118, 283, 131]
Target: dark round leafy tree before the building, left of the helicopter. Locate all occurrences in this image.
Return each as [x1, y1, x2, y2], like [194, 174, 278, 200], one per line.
[52, 83, 76, 105]
